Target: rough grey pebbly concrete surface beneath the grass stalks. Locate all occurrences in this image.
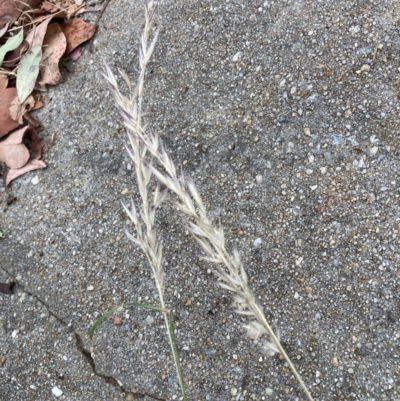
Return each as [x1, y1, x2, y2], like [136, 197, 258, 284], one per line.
[0, 0, 400, 401]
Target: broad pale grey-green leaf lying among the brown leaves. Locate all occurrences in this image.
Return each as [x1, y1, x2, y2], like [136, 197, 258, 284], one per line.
[17, 45, 42, 103]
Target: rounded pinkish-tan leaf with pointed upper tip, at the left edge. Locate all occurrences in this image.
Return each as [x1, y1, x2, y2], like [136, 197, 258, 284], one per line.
[0, 126, 29, 169]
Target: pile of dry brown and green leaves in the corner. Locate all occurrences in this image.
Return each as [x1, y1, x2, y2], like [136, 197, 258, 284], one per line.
[0, 0, 96, 186]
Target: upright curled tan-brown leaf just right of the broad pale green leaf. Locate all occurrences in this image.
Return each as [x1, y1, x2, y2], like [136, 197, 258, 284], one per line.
[39, 23, 67, 85]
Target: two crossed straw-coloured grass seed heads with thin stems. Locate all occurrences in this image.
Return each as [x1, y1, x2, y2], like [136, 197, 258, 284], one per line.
[90, 0, 313, 400]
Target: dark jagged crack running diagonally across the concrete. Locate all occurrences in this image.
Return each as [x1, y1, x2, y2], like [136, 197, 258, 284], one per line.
[1, 267, 165, 401]
